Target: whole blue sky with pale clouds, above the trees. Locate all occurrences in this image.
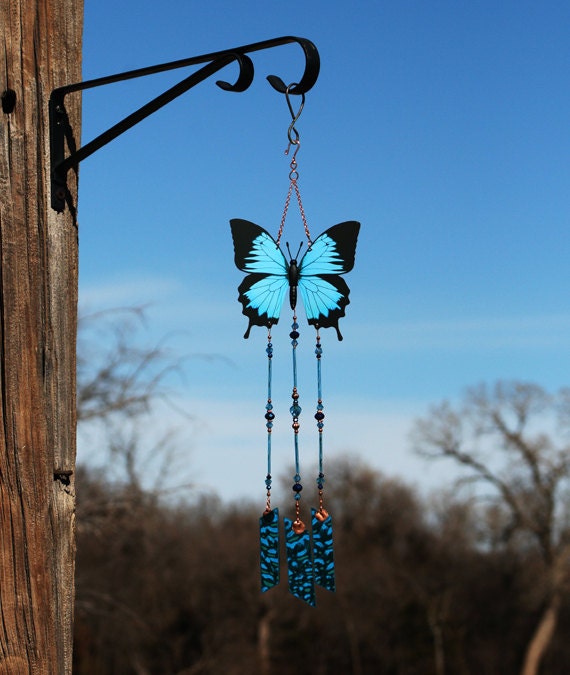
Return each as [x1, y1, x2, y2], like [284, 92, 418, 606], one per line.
[79, 0, 570, 500]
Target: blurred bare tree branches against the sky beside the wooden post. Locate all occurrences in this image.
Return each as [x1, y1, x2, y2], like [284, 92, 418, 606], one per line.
[77, 307, 191, 488]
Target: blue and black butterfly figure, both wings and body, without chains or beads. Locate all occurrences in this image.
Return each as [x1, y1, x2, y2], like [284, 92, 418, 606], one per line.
[230, 218, 360, 340]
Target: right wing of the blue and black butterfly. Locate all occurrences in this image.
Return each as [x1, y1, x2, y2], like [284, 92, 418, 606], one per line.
[299, 220, 360, 340]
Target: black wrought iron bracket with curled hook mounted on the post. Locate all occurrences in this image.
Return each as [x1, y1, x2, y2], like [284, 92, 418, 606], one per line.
[49, 36, 320, 213]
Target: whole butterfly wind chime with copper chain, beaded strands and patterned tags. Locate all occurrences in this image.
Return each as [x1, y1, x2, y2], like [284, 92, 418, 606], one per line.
[230, 84, 360, 606]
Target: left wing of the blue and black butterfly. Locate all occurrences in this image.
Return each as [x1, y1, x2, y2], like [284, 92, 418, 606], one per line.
[230, 218, 289, 338]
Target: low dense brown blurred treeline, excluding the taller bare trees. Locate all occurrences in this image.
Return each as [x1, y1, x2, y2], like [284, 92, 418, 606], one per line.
[74, 461, 570, 675]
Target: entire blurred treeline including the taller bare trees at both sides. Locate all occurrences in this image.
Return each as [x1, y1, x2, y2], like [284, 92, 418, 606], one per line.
[74, 316, 570, 675]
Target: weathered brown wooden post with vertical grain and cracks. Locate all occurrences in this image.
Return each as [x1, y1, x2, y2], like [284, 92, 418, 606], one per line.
[0, 0, 83, 675]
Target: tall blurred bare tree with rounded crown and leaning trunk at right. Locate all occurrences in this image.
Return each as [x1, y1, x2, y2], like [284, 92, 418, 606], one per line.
[413, 382, 570, 675]
